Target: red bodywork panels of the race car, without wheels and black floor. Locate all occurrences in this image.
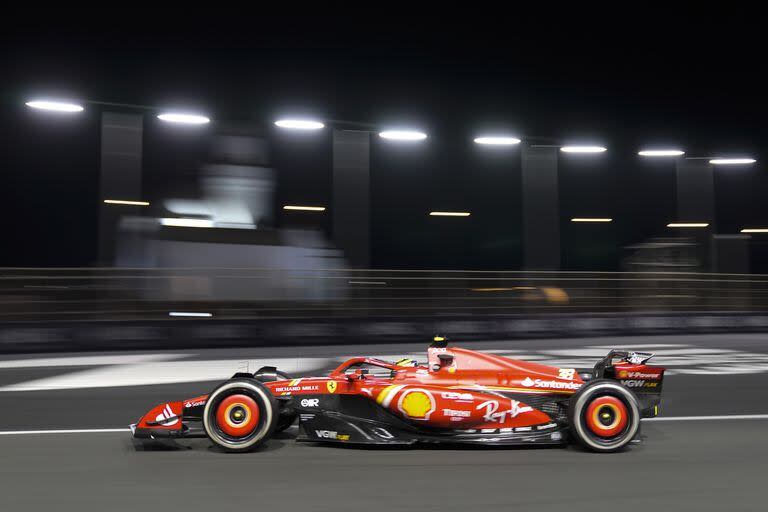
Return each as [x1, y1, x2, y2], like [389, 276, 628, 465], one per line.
[136, 346, 664, 431]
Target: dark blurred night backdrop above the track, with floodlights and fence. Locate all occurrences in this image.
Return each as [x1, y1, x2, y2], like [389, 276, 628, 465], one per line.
[0, 9, 768, 351]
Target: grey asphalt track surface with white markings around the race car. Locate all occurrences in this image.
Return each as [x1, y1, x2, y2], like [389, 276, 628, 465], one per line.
[0, 335, 768, 511]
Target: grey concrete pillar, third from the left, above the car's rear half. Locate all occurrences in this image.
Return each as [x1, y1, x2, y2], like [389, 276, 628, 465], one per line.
[521, 146, 560, 270]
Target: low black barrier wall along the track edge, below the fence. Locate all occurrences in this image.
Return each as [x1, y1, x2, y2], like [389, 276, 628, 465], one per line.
[0, 313, 768, 353]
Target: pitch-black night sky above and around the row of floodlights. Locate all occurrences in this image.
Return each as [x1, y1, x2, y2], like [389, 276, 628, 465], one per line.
[0, 8, 768, 268]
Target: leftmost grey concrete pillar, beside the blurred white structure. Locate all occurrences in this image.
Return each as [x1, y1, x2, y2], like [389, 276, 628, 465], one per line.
[99, 112, 143, 265]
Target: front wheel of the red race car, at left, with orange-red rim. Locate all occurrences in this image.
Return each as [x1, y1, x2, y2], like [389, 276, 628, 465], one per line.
[203, 379, 278, 452]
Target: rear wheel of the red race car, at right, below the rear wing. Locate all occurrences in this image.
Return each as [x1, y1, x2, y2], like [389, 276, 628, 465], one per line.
[568, 379, 640, 452]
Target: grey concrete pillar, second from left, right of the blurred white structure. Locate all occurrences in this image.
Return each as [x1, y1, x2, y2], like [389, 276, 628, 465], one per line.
[331, 130, 371, 268]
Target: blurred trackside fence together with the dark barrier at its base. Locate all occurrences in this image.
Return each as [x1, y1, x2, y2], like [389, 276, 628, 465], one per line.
[0, 268, 768, 351]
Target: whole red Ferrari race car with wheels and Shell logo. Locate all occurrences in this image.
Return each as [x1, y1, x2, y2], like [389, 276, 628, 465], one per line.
[131, 338, 664, 452]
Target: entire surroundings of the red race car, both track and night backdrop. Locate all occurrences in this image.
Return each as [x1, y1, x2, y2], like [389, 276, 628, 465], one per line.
[0, 9, 768, 512]
